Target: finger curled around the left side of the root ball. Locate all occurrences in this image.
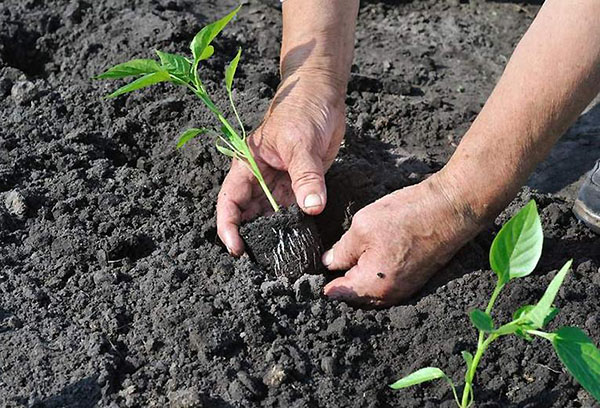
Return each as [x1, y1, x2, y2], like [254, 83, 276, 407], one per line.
[217, 162, 252, 256]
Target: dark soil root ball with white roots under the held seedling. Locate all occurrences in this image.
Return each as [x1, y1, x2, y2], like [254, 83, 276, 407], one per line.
[240, 205, 323, 282]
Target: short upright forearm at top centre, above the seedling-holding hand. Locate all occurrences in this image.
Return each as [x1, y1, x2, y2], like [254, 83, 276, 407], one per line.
[281, 0, 359, 96]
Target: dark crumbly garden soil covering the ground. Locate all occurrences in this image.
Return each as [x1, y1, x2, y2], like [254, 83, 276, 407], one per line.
[0, 0, 600, 408]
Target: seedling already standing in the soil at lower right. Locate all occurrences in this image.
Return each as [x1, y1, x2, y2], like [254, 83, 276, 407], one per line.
[390, 200, 600, 408]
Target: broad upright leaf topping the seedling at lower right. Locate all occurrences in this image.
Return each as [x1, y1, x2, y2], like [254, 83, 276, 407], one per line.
[490, 200, 544, 283]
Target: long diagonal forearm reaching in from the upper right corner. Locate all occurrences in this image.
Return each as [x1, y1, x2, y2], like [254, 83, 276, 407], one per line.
[441, 0, 600, 220]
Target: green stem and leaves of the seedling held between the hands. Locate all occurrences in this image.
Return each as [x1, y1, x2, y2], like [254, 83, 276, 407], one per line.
[95, 6, 279, 211]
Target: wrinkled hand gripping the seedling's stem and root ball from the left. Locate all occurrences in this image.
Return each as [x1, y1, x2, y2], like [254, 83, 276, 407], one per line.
[217, 72, 345, 256]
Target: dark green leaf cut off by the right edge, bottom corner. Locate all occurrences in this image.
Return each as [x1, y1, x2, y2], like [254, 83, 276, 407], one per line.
[552, 327, 600, 402]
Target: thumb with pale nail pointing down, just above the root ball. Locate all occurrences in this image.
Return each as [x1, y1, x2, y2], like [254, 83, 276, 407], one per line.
[288, 150, 327, 215]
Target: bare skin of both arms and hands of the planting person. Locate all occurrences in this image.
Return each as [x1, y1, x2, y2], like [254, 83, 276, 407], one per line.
[217, 0, 600, 306]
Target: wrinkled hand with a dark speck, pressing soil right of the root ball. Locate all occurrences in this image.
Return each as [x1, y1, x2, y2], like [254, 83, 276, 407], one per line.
[323, 173, 479, 306]
